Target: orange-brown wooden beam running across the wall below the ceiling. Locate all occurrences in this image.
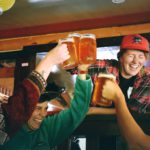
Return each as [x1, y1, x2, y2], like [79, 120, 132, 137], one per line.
[0, 23, 150, 52]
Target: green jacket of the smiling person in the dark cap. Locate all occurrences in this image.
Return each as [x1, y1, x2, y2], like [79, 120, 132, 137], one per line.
[2, 76, 92, 150]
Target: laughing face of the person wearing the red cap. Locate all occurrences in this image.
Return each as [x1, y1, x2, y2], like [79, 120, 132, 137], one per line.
[120, 50, 146, 79]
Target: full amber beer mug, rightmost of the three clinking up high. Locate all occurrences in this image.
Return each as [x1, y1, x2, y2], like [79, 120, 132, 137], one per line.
[79, 34, 96, 64]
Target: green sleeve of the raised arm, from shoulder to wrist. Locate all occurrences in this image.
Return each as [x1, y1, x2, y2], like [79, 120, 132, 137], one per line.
[45, 76, 92, 148]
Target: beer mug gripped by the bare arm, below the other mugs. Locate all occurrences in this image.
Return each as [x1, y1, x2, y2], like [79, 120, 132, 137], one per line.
[91, 73, 116, 107]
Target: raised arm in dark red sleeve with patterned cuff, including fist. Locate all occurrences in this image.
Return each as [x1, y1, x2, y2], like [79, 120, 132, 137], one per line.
[3, 44, 70, 134]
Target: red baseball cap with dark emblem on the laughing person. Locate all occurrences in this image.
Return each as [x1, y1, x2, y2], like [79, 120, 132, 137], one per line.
[120, 34, 150, 52]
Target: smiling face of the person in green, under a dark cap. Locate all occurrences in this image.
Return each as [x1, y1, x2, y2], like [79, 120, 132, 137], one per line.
[28, 101, 48, 130]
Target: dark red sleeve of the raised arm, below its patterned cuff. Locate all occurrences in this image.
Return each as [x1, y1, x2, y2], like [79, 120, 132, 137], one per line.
[3, 79, 40, 136]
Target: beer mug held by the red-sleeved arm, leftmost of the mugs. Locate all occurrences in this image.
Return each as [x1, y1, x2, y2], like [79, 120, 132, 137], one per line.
[58, 37, 78, 69]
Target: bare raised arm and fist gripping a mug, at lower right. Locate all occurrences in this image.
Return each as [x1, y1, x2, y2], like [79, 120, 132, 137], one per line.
[103, 80, 150, 150]
